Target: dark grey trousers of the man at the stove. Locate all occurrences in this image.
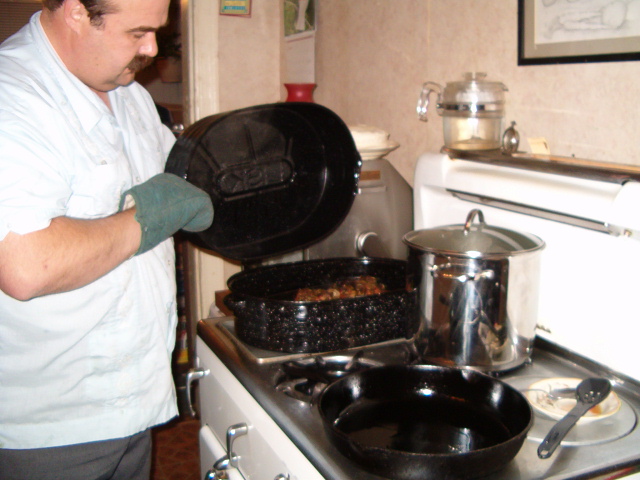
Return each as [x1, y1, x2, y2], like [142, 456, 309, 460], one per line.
[0, 430, 151, 480]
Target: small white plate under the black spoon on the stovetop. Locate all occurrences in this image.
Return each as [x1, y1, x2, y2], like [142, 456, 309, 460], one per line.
[524, 378, 621, 423]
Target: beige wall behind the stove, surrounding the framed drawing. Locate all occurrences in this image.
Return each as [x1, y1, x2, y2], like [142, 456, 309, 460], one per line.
[315, 0, 640, 185]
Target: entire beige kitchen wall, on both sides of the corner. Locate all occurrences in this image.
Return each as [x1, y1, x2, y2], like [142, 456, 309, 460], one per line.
[176, 0, 640, 316]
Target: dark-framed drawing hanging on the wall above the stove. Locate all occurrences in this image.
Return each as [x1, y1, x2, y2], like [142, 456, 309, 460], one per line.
[518, 0, 640, 65]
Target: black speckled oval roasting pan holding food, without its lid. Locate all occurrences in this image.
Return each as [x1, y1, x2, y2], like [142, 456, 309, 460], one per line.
[225, 258, 419, 353]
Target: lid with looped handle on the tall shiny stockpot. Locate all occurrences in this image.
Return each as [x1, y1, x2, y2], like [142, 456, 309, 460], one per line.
[403, 209, 545, 258]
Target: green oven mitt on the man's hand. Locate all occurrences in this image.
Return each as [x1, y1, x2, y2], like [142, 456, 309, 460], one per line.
[120, 173, 213, 255]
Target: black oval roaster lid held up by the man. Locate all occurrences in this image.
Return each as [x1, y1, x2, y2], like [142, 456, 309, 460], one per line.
[165, 103, 362, 261]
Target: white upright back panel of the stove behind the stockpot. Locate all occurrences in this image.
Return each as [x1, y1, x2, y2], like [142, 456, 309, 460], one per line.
[414, 152, 640, 379]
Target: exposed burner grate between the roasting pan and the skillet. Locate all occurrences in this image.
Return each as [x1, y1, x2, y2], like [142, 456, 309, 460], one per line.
[276, 350, 383, 405]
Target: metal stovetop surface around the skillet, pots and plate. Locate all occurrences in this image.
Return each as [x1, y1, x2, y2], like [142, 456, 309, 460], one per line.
[198, 317, 640, 480]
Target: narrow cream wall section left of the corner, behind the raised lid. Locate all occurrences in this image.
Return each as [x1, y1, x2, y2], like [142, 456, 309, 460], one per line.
[181, 0, 284, 322]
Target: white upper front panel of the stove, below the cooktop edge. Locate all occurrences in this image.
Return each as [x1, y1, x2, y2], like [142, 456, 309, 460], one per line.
[196, 337, 323, 480]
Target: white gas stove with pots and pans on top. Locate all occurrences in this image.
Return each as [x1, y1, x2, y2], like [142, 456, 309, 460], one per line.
[193, 153, 640, 480]
